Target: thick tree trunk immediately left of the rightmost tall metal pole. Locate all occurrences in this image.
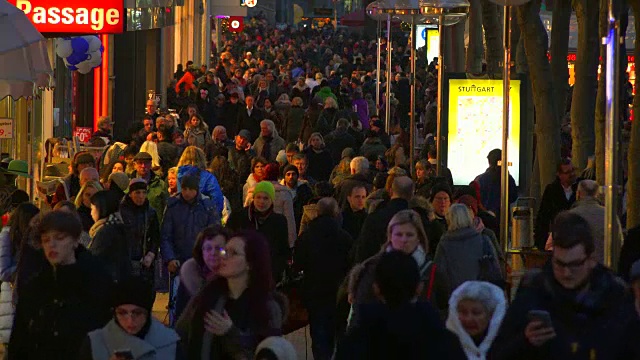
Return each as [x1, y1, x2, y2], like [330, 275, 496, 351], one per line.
[571, 0, 600, 171]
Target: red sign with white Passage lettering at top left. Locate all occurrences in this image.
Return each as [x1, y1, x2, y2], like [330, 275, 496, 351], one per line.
[9, 0, 125, 34]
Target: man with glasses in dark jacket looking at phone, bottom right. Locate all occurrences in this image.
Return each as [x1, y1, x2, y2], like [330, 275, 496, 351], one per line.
[487, 211, 640, 359]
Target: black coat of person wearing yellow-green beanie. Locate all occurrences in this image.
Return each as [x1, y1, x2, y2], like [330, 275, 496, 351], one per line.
[227, 206, 291, 284]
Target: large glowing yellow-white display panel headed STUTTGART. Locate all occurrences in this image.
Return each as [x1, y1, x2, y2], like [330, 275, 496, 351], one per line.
[445, 79, 521, 185]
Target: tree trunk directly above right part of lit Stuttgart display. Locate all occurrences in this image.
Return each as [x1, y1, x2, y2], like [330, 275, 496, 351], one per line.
[482, 0, 504, 75]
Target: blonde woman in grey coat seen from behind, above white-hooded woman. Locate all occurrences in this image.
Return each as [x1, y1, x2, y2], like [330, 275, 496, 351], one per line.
[434, 204, 500, 298]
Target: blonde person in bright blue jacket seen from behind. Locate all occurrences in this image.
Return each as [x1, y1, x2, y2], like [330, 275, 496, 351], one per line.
[178, 146, 224, 213]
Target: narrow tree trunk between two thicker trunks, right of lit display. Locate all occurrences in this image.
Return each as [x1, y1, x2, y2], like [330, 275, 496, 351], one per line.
[549, 0, 571, 117]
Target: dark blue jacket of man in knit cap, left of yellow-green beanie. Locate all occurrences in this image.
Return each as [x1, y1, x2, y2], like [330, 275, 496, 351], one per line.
[160, 194, 220, 263]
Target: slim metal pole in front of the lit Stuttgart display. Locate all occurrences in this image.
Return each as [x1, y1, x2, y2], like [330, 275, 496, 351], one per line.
[500, 5, 511, 250]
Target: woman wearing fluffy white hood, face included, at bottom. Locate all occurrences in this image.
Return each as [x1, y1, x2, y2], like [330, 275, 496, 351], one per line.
[447, 281, 507, 360]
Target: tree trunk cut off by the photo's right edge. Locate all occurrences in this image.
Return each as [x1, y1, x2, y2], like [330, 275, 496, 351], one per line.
[627, 0, 640, 229]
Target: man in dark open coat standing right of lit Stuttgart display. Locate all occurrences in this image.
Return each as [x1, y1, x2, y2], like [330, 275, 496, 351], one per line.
[534, 158, 577, 249]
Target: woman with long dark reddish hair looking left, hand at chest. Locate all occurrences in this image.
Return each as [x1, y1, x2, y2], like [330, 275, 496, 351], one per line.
[176, 232, 284, 359]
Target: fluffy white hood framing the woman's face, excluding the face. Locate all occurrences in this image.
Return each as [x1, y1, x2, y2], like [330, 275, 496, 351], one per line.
[447, 281, 507, 360]
